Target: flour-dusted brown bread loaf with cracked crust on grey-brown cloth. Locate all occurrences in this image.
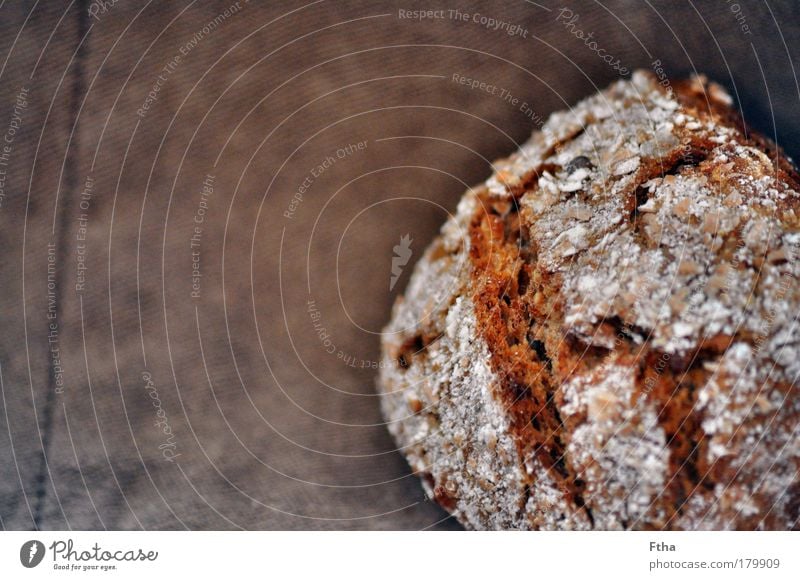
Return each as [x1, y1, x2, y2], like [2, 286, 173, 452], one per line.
[379, 72, 800, 530]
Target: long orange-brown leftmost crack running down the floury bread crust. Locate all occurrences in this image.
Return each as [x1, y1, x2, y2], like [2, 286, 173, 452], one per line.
[470, 188, 592, 523]
